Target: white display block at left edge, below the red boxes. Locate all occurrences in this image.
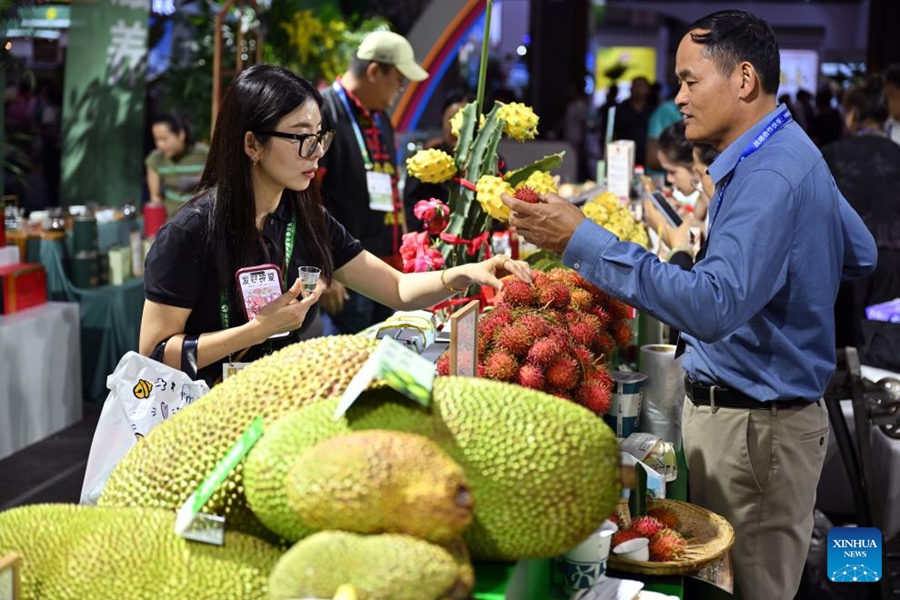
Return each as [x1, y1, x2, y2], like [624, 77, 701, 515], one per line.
[0, 302, 82, 459]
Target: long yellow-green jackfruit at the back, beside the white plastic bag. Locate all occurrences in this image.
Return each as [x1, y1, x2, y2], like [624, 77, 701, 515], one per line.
[98, 336, 378, 536]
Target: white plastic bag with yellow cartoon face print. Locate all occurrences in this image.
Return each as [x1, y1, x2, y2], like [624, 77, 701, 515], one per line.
[81, 352, 209, 505]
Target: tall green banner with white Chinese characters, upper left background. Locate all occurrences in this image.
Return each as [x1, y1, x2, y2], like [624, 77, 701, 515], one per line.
[60, 0, 150, 206]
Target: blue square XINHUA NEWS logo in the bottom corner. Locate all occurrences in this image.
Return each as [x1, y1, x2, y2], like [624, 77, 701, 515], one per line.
[828, 527, 881, 583]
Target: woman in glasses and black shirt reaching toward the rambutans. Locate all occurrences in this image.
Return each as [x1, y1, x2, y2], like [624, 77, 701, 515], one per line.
[140, 65, 530, 385]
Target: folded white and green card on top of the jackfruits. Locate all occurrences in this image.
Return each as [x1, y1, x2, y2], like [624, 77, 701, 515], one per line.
[333, 338, 435, 421]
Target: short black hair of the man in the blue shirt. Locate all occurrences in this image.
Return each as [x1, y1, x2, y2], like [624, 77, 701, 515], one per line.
[687, 10, 781, 96]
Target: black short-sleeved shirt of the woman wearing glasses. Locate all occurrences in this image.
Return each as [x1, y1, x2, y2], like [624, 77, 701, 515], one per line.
[144, 191, 363, 384]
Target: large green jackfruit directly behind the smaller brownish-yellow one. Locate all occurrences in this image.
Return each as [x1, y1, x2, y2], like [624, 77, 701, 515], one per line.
[244, 377, 620, 560]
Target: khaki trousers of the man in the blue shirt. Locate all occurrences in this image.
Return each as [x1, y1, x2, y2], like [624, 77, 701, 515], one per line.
[682, 398, 829, 600]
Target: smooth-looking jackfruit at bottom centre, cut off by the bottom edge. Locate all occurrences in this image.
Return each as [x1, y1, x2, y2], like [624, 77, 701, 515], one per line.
[269, 531, 469, 600]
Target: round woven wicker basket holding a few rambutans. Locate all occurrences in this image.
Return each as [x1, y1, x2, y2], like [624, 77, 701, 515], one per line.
[609, 500, 734, 575]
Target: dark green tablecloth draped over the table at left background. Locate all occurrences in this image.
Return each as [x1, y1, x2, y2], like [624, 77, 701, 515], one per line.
[27, 233, 144, 403]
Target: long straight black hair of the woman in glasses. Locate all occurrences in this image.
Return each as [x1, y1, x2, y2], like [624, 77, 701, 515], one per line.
[192, 64, 334, 290]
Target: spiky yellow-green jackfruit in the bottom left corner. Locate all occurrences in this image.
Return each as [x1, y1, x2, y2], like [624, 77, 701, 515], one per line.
[0, 504, 282, 600]
